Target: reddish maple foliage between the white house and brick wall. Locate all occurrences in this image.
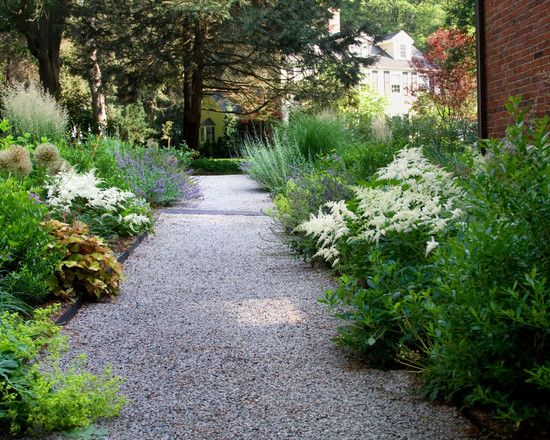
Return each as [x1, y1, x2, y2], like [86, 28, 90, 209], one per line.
[411, 29, 477, 119]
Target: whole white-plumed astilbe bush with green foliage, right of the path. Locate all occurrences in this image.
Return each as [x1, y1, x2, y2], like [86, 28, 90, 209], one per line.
[297, 148, 462, 365]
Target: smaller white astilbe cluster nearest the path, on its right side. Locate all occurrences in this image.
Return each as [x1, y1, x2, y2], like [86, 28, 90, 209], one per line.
[297, 200, 357, 265]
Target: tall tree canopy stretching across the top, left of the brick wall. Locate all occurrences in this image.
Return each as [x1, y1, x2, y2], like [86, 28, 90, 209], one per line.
[0, 0, 474, 148]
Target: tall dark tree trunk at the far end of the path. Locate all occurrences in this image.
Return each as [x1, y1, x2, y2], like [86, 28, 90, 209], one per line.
[183, 22, 206, 150]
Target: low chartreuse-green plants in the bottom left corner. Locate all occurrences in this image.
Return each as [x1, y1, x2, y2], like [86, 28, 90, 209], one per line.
[0, 308, 125, 437]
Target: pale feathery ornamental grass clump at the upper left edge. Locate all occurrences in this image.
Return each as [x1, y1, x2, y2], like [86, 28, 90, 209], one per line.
[2, 84, 68, 142]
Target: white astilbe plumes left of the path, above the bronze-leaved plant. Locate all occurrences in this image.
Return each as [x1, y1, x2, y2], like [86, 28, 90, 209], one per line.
[46, 169, 135, 212]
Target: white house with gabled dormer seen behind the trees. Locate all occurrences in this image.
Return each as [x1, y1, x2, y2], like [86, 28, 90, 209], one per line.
[352, 31, 434, 116]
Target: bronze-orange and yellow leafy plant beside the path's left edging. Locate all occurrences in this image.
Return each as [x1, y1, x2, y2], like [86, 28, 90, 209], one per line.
[47, 220, 122, 299]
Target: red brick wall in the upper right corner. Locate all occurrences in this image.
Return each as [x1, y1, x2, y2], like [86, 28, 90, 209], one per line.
[481, 0, 550, 136]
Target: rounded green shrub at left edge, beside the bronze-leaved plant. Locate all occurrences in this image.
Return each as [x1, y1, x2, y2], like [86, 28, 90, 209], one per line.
[0, 178, 61, 303]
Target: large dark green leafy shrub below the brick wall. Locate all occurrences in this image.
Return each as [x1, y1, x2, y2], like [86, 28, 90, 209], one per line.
[418, 99, 550, 432]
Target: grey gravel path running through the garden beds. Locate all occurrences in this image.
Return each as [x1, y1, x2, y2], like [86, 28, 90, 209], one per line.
[54, 176, 478, 440]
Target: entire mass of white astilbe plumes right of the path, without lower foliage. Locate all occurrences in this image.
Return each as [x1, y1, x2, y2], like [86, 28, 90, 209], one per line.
[299, 148, 462, 261]
